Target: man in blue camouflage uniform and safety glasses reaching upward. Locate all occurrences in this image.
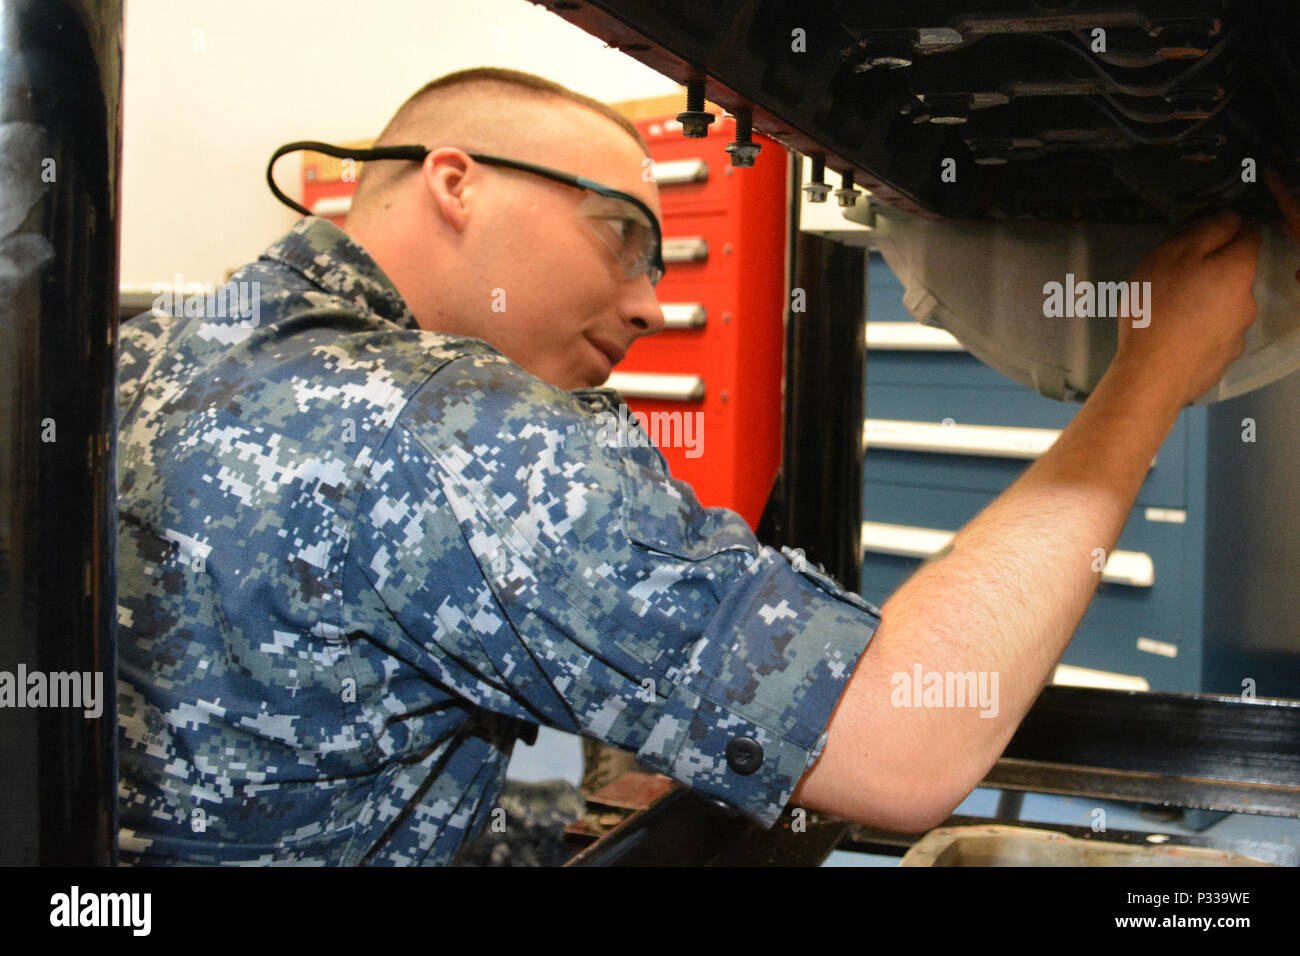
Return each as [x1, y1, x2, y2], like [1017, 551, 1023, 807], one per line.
[118, 63, 1284, 864]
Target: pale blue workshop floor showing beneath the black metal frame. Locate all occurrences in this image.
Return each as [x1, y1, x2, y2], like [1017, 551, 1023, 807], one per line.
[506, 727, 1300, 866]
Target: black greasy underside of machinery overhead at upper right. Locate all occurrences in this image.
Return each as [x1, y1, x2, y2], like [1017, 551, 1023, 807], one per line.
[534, 0, 1300, 221]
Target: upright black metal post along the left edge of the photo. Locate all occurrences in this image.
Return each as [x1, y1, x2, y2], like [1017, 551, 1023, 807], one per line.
[0, 0, 122, 865]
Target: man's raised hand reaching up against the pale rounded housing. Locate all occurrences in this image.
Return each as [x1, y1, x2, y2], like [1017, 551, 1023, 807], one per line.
[1115, 212, 1260, 405]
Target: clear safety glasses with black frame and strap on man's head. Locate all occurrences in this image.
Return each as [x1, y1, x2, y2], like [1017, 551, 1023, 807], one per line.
[267, 140, 663, 285]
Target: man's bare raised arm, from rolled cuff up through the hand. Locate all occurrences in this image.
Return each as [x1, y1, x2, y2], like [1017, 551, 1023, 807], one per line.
[794, 213, 1260, 831]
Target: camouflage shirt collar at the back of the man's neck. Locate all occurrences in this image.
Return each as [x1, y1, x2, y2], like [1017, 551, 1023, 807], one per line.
[261, 216, 420, 330]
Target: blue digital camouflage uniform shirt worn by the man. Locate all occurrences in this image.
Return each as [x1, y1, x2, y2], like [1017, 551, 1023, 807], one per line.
[117, 219, 880, 865]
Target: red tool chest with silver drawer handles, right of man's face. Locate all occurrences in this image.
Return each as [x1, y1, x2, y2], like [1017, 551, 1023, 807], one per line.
[610, 117, 788, 527]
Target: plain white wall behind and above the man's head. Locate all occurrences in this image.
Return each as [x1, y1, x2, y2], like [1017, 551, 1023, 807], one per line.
[121, 0, 677, 285]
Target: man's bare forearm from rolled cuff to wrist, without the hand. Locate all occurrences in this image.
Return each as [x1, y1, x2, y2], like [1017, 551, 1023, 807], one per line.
[800, 362, 1180, 829]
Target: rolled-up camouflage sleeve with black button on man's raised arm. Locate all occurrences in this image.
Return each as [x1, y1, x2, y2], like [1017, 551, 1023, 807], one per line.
[359, 355, 880, 826]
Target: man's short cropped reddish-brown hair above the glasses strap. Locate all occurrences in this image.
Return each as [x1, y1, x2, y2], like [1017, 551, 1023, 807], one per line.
[352, 66, 650, 209]
